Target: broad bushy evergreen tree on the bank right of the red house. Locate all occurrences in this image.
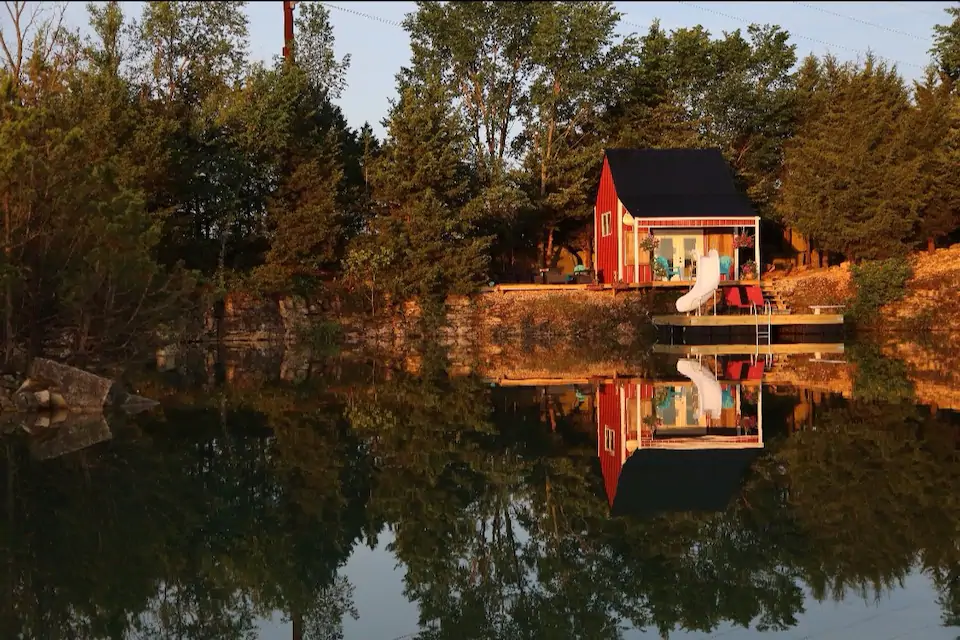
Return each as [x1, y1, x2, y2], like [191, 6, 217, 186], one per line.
[778, 58, 920, 259]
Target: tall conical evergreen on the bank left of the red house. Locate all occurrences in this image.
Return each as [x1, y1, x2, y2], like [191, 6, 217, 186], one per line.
[351, 70, 489, 300]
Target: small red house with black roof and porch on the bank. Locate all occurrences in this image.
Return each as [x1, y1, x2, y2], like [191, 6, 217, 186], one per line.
[594, 149, 760, 283]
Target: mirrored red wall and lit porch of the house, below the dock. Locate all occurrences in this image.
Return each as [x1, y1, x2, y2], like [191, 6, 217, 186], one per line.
[596, 364, 763, 507]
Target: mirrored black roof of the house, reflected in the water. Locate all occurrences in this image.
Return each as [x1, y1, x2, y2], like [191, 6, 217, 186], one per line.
[613, 449, 761, 518]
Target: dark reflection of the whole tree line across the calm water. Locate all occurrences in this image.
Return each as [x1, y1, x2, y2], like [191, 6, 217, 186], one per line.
[0, 371, 960, 640]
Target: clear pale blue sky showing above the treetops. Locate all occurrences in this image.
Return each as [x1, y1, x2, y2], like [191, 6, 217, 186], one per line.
[26, 0, 953, 135]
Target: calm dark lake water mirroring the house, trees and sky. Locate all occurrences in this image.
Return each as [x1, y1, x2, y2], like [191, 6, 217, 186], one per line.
[0, 340, 960, 640]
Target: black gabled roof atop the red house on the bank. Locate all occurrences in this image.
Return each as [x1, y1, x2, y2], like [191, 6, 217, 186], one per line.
[605, 149, 756, 218]
